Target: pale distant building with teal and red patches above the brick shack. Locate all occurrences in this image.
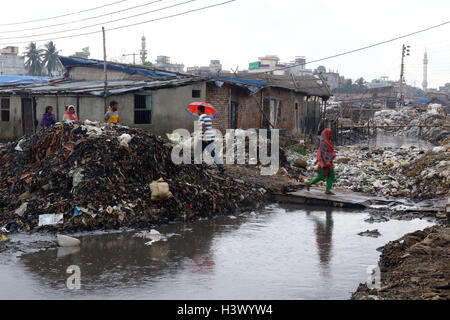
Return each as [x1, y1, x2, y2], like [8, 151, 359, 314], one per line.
[248, 55, 312, 76]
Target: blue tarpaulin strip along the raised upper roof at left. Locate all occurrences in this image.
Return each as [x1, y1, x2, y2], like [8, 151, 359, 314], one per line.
[59, 56, 178, 79]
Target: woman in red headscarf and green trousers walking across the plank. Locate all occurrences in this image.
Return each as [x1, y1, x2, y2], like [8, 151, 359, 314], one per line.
[306, 129, 336, 195]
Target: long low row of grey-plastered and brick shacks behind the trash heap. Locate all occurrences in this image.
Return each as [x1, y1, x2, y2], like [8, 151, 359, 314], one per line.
[0, 57, 330, 137]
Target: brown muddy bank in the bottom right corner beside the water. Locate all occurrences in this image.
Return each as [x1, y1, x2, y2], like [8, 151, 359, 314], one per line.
[352, 226, 450, 300]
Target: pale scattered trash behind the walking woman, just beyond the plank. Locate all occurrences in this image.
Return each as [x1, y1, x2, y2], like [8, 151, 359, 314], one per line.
[288, 145, 450, 200]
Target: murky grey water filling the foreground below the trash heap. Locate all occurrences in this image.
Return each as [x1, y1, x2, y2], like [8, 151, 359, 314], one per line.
[0, 205, 431, 300]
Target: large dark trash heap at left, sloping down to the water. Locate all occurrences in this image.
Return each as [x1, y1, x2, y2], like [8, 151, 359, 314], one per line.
[0, 123, 265, 231]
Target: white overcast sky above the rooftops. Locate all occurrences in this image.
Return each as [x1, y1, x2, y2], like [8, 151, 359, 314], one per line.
[0, 0, 450, 88]
